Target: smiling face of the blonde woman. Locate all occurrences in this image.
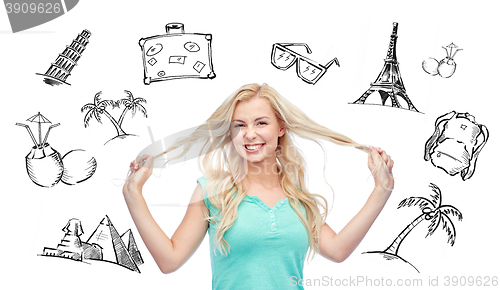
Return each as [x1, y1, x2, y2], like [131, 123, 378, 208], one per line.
[231, 97, 285, 164]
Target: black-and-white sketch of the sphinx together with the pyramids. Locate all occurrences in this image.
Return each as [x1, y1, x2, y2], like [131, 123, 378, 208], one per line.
[40, 215, 144, 273]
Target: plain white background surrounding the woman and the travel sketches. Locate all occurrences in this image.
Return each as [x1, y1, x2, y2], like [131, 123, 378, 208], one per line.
[0, 1, 500, 289]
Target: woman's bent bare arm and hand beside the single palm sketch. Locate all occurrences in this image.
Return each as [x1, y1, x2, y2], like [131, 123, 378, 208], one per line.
[319, 148, 394, 262]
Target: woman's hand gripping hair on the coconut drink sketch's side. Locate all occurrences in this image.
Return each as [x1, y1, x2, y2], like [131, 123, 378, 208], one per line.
[123, 154, 154, 195]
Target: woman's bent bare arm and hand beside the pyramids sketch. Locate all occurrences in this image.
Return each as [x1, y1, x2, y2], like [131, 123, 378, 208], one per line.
[123, 156, 208, 274]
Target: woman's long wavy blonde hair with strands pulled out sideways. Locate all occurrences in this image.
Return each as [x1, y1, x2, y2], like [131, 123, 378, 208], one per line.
[158, 84, 385, 257]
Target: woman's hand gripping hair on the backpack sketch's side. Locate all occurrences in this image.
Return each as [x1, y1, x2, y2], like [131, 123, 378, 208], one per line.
[368, 146, 394, 191]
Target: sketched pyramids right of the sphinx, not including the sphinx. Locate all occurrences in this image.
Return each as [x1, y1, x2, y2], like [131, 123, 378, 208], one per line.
[87, 215, 140, 273]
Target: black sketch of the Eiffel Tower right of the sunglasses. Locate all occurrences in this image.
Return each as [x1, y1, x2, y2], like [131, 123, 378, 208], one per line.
[351, 22, 419, 112]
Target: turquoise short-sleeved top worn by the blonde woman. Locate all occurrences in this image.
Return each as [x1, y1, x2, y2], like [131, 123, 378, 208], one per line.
[197, 177, 309, 290]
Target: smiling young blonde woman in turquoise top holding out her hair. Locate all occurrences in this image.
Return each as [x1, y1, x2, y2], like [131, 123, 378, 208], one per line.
[123, 84, 394, 289]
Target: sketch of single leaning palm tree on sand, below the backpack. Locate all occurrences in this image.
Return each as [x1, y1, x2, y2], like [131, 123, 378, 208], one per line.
[363, 183, 463, 273]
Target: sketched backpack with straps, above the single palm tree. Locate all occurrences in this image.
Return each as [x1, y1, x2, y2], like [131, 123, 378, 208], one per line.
[424, 111, 489, 181]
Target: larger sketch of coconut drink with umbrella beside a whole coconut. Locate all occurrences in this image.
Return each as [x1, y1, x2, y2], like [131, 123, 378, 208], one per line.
[16, 112, 97, 187]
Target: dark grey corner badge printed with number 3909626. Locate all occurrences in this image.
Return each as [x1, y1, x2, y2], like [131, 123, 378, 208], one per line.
[3, 0, 79, 33]
